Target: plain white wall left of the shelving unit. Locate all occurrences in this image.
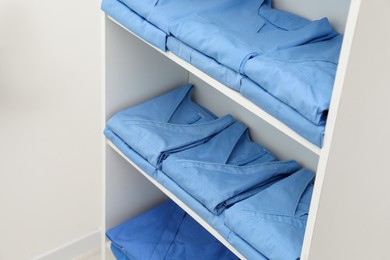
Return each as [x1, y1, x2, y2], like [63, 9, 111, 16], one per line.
[0, 0, 102, 260]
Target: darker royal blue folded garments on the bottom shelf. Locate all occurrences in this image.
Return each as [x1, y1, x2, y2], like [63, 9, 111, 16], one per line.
[107, 200, 238, 260]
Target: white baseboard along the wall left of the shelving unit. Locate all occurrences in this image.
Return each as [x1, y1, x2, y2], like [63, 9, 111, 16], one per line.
[31, 229, 102, 260]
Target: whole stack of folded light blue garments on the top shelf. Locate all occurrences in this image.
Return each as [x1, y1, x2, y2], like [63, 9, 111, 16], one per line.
[102, 0, 342, 147]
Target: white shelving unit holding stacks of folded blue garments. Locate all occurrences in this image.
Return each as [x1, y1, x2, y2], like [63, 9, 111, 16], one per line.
[102, 0, 390, 259]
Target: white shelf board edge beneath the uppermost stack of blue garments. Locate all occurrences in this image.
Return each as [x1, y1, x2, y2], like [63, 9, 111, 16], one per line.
[108, 16, 321, 155]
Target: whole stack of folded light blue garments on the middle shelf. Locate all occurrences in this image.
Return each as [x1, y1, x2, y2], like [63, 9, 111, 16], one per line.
[105, 84, 314, 259]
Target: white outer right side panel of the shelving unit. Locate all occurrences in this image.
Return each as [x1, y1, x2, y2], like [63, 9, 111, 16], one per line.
[302, 0, 390, 260]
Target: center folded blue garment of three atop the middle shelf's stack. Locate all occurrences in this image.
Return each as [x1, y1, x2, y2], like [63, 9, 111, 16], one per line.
[162, 120, 300, 214]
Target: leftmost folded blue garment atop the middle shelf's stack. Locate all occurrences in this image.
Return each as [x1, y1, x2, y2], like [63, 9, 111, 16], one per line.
[107, 84, 235, 167]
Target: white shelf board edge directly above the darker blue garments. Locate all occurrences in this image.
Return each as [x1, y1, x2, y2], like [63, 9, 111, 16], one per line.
[106, 140, 245, 259]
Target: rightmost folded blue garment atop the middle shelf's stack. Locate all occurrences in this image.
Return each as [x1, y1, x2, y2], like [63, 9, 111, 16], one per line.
[225, 169, 314, 259]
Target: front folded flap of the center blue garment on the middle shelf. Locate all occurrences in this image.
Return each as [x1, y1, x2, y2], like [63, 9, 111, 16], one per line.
[162, 155, 299, 214]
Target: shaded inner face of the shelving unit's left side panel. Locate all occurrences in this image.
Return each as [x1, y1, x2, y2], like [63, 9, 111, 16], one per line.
[104, 15, 188, 232]
